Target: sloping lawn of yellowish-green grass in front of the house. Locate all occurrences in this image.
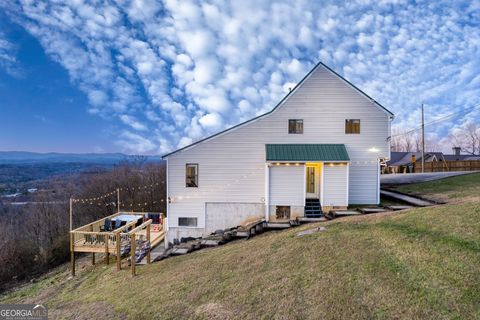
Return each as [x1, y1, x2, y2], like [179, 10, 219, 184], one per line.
[0, 175, 480, 319]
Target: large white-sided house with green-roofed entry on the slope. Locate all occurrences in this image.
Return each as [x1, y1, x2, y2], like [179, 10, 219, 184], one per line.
[163, 63, 393, 241]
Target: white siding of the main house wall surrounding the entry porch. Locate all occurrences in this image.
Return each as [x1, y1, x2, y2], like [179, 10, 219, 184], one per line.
[167, 65, 390, 241]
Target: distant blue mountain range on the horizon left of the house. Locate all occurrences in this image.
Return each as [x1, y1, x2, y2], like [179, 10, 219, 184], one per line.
[0, 151, 160, 164]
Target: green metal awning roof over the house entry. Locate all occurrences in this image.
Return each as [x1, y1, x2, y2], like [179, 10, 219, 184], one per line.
[265, 144, 350, 161]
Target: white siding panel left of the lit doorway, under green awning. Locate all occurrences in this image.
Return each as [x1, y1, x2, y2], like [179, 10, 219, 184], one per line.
[270, 165, 305, 206]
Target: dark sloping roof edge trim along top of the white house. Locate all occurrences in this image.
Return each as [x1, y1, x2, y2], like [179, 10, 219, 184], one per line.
[162, 61, 394, 159]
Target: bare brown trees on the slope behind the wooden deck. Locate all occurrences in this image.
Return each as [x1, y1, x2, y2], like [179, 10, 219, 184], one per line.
[0, 158, 166, 290]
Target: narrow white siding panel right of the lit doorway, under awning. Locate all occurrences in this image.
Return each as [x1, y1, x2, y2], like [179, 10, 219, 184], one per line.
[322, 164, 348, 206]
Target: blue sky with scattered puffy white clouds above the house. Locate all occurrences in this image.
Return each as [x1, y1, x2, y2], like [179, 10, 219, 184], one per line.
[0, 0, 480, 154]
